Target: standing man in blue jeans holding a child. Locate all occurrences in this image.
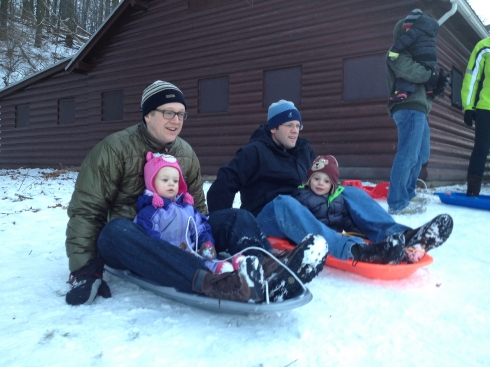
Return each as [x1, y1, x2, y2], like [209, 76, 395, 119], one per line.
[386, 19, 448, 214]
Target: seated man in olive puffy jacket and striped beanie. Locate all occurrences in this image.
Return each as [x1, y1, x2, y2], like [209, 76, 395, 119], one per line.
[66, 80, 296, 305]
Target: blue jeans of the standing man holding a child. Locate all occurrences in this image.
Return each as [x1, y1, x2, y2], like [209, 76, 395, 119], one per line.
[387, 110, 430, 210]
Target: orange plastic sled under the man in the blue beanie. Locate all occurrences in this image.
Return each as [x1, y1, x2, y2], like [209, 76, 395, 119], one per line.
[268, 237, 434, 280]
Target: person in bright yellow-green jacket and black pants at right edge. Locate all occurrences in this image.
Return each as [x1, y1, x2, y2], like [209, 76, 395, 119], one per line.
[461, 37, 490, 196]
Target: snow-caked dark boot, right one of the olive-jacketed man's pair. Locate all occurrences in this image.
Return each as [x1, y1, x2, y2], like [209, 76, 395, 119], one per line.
[262, 234, 328, 302]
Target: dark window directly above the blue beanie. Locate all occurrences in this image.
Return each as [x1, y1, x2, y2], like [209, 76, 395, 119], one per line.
[264, 66, 302, 107]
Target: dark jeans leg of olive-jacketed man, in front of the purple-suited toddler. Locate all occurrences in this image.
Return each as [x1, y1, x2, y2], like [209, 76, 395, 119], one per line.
[97, 218, 208, 292]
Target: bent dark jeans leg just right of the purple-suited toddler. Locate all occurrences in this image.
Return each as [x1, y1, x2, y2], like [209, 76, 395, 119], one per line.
[208, 209, 272, 256]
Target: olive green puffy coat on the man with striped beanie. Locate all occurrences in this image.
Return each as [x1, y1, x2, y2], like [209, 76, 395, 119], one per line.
[66, 123, 207, 271]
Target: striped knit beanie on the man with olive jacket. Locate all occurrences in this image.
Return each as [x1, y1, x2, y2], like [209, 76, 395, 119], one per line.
[141, 80, 187, 122]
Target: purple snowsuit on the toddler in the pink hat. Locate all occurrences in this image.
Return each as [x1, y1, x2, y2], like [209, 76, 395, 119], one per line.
[134, 190, 219, 273]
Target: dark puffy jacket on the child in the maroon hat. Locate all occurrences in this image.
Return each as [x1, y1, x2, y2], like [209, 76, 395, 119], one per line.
[292, 186, 362, 233]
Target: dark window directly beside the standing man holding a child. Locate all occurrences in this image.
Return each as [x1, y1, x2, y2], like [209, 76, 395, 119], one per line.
[343, 55, 388, 101]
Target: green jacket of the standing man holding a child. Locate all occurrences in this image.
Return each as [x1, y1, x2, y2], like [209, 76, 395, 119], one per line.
[386, 19, 434, 116]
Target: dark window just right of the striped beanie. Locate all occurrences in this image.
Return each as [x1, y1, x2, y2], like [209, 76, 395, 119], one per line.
[199, 76, 229, 113]
